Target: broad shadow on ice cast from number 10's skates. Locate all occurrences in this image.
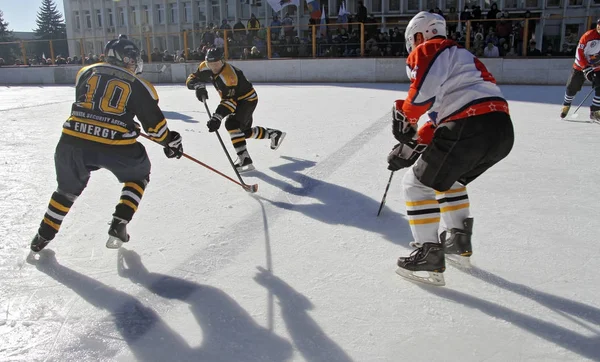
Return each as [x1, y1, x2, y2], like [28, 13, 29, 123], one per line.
[30, 249, 292, 362]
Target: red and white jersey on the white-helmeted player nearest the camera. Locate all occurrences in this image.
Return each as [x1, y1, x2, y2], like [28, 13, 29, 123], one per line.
[402, 38, 508, 126]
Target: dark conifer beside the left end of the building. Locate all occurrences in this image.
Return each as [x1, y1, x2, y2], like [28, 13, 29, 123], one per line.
[34, 0, 69, 57]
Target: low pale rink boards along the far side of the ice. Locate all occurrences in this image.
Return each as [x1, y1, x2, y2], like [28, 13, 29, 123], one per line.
[0, 58, 573, 85]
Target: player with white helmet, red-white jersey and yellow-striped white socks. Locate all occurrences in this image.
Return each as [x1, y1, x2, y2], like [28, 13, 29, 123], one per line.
[388, 11, 514, 285]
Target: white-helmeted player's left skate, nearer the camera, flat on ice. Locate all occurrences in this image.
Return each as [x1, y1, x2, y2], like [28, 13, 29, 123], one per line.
[396, 243, 446, 286]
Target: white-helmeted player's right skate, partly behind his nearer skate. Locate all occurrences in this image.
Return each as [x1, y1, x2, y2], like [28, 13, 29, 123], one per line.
[440, 217, 473, 267]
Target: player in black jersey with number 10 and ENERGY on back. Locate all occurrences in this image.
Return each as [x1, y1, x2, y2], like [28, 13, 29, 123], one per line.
[31, 39, 183, 252]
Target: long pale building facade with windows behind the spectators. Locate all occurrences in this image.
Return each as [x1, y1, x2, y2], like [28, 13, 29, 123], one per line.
[64, 0, 600, 55]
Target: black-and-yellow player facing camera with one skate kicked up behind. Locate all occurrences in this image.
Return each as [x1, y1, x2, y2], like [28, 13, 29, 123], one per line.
[186, 48, 285, 172]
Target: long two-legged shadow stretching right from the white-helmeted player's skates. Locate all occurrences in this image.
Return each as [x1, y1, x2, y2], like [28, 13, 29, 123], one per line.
[419, 266, 600, 361]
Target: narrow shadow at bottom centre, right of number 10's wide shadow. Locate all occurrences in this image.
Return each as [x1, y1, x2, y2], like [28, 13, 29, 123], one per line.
[254, 267, 352, 362]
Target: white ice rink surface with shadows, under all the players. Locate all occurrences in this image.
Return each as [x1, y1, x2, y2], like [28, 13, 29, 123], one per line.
[0, 84, 600, 362]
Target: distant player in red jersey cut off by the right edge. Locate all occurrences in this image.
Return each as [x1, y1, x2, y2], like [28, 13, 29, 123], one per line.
[560, 18, 600, 121]
